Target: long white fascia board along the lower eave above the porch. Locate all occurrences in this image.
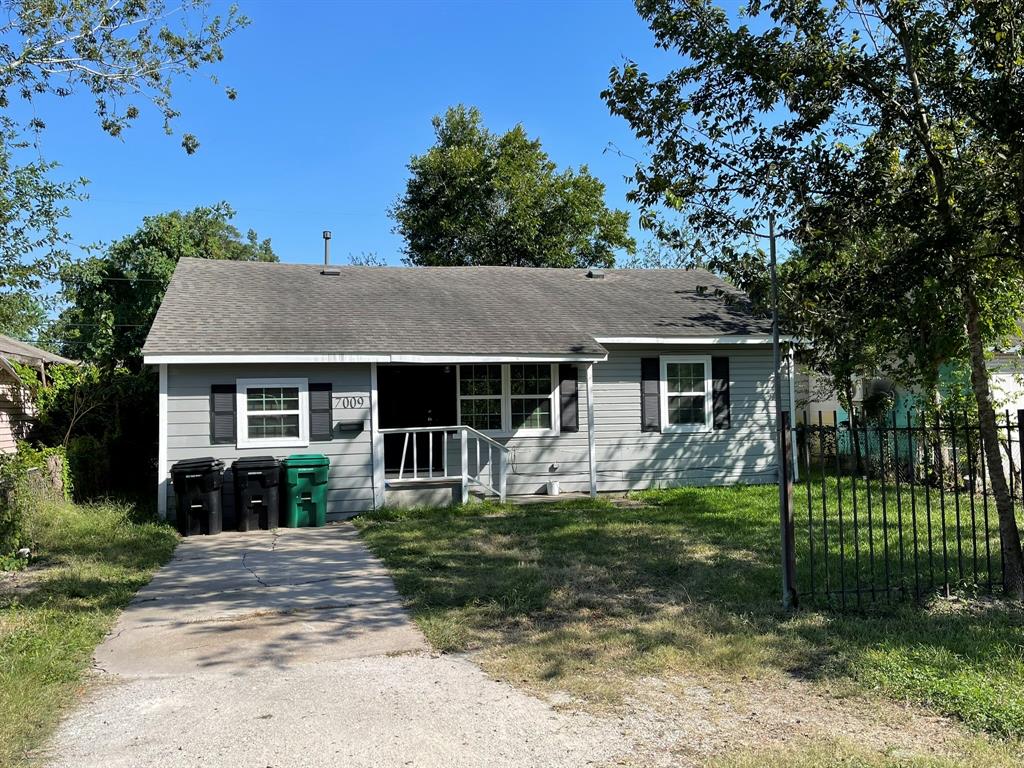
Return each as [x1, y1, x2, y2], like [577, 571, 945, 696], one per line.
[143, 353, 608, 366]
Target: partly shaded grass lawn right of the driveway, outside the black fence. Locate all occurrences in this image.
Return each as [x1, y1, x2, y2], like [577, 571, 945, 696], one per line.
[356, 486, 1024, 740]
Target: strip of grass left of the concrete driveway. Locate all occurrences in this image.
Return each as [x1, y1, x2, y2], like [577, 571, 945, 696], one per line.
[0, 502, 177, 766]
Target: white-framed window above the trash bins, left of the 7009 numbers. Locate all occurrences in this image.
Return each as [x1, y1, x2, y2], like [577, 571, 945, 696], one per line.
[236, 379, 309, 447]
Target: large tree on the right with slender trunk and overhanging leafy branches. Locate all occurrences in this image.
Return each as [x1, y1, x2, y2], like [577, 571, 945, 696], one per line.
[603, 0, 1024, 598]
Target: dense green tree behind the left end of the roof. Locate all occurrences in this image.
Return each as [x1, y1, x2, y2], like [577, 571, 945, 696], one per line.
[53, 203, 278, 371]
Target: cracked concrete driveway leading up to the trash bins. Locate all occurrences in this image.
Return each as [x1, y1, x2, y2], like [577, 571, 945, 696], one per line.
[46, 523, 629, 768]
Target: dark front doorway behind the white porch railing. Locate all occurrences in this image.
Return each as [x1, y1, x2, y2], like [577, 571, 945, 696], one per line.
[377, 366, 458, 473]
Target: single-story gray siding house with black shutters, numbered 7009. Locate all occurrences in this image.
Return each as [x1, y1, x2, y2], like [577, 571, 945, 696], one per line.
[143, 259, 793, 517]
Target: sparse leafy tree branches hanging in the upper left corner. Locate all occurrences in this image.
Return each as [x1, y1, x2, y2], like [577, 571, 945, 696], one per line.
[0, 0, 248, 309]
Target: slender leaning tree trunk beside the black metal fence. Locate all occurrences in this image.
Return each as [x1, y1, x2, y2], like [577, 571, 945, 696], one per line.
[966, 290, 1024, 600]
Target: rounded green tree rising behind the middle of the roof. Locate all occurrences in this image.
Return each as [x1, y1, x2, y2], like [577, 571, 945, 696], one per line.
[390, 105, 636, 267]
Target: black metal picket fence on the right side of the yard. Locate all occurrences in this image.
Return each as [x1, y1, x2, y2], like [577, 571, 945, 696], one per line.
[791, 411, 1024, 607]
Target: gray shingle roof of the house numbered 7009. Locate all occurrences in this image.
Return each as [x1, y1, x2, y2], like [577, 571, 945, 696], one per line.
[143, 259, 770, 355]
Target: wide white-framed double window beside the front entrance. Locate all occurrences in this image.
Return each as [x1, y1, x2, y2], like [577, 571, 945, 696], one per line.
[459, 362, 558, 435]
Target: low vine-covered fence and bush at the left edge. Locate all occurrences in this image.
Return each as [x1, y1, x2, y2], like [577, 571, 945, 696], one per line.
[0, 442, 71, 569]
